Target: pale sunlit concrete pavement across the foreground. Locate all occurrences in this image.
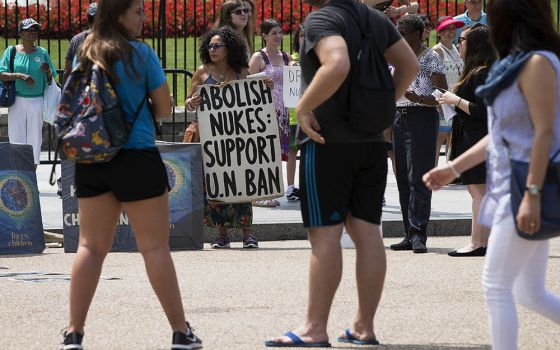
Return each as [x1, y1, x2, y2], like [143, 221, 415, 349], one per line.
[0, 237, 560, 350]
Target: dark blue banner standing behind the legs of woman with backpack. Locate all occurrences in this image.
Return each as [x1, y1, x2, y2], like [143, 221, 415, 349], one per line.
[62, 142, 204, 253]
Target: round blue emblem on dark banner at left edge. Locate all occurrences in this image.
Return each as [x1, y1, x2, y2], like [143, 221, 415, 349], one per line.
[0, 176, 33, 217]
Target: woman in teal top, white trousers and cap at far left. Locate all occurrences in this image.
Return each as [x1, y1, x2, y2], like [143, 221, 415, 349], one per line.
[0, 18, 56, 164]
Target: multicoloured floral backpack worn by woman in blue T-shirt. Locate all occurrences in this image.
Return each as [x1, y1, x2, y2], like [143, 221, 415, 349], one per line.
[51, 65, 147, 187]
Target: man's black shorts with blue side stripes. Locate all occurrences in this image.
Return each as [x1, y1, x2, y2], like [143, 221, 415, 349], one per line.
[299, 141, 387, 227]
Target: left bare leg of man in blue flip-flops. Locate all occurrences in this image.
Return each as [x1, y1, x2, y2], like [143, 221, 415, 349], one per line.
[266, 224, 342, 343]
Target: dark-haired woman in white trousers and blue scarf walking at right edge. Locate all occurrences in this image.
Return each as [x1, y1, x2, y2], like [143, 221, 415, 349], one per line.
[424, 0, 560, 350]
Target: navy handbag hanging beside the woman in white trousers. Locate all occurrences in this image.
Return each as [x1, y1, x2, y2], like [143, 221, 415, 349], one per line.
[510, 150, 560, 240]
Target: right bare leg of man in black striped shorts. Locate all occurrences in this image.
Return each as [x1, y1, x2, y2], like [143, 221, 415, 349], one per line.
[342, 215, 387, 340]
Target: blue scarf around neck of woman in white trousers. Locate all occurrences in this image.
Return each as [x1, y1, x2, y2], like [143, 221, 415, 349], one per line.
[476, 51, 535, 106]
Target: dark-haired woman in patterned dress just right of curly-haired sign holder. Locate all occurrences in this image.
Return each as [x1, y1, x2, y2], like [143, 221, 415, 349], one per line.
[249, 19, 293, 207]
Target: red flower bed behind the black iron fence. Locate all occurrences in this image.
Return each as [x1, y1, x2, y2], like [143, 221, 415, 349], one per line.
[0, 0, 464, 38]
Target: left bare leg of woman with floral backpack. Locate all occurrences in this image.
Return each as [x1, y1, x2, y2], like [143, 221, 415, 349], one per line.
[68, 193, 121, 333]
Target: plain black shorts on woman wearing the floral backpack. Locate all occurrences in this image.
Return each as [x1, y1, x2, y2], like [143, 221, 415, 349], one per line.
[74, 148, 169, 202]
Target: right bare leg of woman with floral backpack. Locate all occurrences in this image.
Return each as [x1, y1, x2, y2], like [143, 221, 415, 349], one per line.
[122, 193, 187, 332]
